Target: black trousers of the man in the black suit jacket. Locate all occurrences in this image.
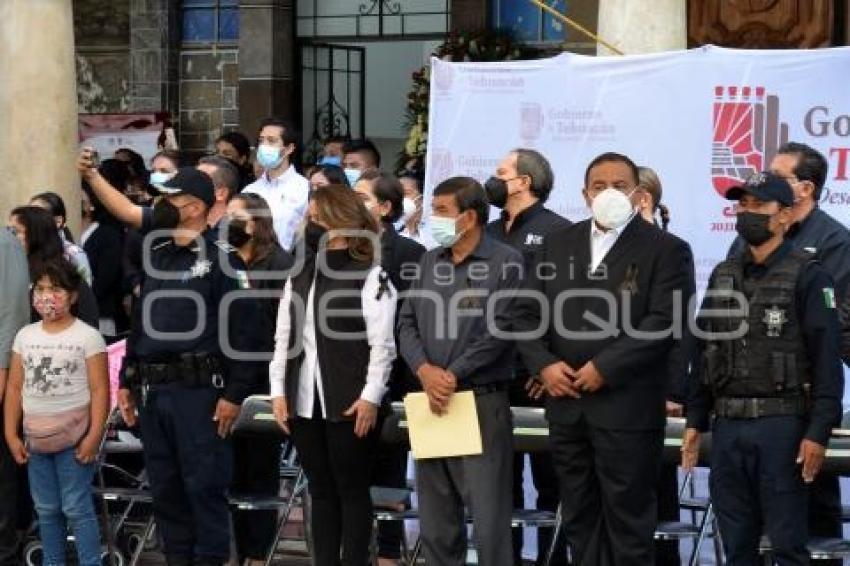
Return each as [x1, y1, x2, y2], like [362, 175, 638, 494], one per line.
[549, 419, 664, 566]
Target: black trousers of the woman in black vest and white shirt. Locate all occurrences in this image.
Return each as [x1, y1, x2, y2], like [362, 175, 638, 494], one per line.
[291, 414, 377, 566]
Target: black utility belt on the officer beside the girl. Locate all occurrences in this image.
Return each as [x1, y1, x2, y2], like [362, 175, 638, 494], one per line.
[125, 353, 226, 389]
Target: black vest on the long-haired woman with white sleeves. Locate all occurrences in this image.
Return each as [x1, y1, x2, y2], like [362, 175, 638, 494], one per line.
[286, 250, 372, 421]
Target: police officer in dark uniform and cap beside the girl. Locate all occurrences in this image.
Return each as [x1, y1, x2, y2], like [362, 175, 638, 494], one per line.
[119, 167, 261, 566]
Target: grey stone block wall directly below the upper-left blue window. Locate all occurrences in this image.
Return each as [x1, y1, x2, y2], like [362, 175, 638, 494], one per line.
[179, 48, 239, 154]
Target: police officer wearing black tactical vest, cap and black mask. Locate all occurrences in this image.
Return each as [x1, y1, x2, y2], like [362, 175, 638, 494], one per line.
[682, 173, 844, 566]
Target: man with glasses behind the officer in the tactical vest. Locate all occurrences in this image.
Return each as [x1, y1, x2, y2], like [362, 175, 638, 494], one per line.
[727, 142, 850, 566]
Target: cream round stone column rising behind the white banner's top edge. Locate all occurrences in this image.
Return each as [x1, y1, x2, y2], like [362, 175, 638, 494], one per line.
[596, 0, 688, 55]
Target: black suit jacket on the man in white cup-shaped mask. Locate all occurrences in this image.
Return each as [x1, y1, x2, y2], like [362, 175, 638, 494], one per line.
[516, 217, 694, 430]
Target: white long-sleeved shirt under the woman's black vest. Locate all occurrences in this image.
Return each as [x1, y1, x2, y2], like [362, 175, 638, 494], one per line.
[269, 266, 396, 419]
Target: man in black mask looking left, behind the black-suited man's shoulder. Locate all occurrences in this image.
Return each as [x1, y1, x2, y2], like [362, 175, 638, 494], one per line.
[484, 148, 571, 566]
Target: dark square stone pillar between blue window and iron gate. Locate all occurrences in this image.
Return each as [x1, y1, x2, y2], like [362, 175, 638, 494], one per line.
[239, 0, 300, 139]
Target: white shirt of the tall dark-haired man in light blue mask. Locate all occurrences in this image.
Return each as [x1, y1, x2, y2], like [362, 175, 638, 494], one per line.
[242, 165, 310, 250]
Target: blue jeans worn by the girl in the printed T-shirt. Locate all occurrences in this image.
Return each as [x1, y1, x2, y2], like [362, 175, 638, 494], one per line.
[28, 448, 100, 566]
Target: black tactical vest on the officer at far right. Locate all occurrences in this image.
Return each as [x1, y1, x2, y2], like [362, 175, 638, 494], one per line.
[703, 250, 812, 398]
